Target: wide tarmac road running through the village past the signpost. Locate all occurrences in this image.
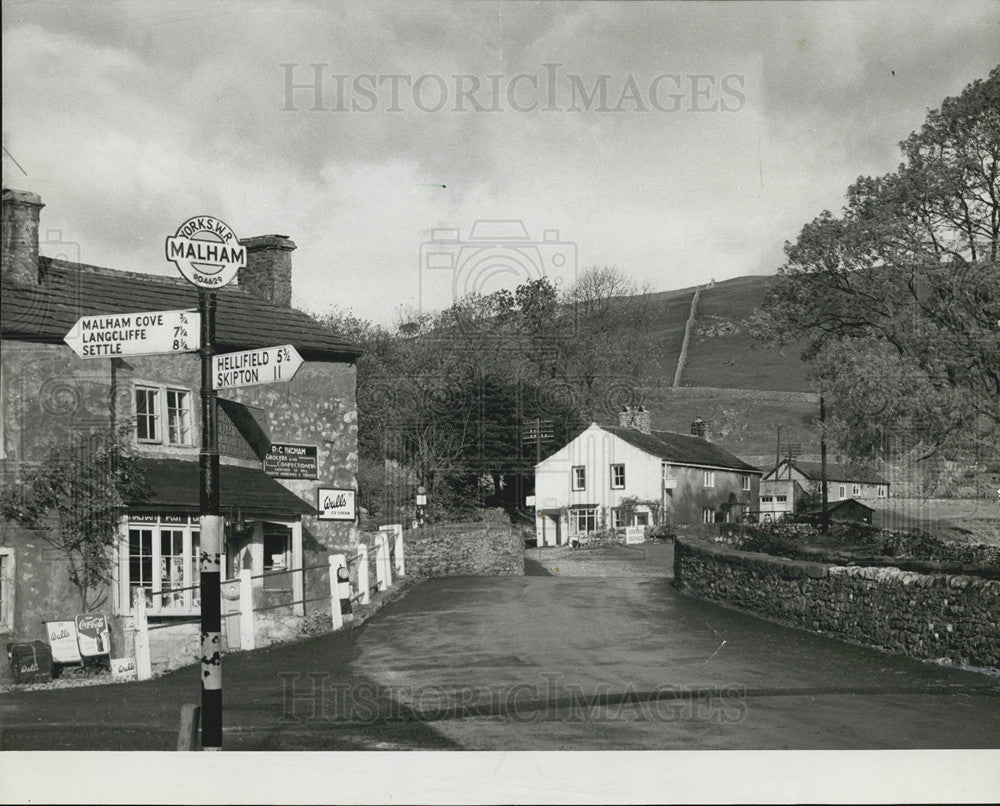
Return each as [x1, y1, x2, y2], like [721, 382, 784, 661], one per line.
[0, 548, 1000, 750]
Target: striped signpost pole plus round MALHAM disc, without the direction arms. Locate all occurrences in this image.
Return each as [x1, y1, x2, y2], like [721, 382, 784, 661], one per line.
[166, 216, 247, 750]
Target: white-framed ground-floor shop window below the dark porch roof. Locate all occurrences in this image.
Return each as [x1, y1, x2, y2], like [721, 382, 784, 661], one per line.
[120, 516, 201, 615]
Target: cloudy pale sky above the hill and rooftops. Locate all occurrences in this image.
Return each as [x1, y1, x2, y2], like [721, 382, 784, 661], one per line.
[3, 0, 1000, 323]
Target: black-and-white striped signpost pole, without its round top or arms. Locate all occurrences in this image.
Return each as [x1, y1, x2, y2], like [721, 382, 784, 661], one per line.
[198, 290, 223, 750]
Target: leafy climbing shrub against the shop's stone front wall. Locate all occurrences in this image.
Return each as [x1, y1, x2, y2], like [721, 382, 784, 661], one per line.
[0, 429, 148, 613]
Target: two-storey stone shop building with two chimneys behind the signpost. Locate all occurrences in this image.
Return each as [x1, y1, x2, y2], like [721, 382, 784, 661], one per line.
[0, 189, 359, 656]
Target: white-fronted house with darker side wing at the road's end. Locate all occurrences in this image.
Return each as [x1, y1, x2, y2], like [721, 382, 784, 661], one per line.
[535, 409, 761, 546]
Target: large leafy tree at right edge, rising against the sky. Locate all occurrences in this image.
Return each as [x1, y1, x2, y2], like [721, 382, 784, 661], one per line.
[766, 67, 1000, 458]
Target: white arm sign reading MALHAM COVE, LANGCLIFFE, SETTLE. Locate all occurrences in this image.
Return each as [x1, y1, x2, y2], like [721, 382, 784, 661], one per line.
[63, 311, 201, 358]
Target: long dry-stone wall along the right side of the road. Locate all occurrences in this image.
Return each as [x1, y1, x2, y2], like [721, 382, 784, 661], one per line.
[674, 538, 1000, 668]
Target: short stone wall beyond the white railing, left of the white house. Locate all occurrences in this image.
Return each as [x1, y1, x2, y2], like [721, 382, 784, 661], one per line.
[400, 523, 524, 577]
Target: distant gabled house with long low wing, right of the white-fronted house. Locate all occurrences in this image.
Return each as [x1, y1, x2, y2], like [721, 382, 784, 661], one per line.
[760, 459, 889, 520]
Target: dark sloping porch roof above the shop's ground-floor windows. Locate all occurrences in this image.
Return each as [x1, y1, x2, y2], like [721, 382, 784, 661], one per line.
[128, 458, 317, 517]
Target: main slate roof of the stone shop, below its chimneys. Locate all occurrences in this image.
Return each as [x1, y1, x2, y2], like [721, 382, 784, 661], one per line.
[0, 257, 361, 361]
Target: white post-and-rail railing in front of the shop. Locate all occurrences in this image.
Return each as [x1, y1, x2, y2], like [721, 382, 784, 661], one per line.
[132, 526, 406, 680]
